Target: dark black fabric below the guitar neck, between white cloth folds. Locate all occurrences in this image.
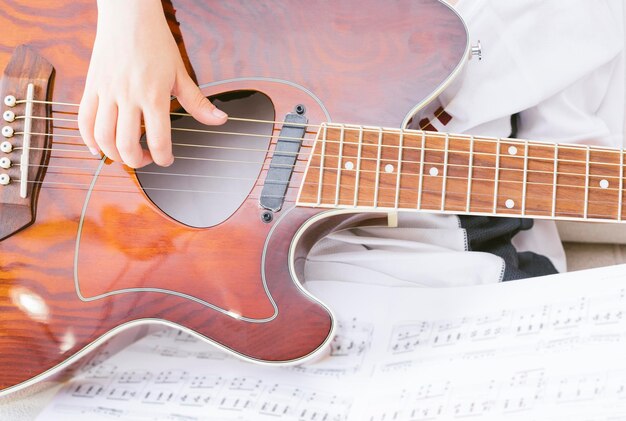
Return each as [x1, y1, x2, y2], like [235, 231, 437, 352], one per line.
[459, 216, 557, 281]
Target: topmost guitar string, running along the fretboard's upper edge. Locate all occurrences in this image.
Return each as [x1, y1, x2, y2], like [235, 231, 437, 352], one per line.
[9, 100, 623, 158]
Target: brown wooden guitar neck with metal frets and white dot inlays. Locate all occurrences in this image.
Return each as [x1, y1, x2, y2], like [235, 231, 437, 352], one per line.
[297, 124, 625, 221]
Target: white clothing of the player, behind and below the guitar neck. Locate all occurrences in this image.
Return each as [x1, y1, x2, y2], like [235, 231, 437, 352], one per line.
[305, 0, 624, 286]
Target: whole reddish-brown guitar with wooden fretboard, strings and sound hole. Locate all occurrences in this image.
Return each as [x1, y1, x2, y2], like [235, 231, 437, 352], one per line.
[0, 0, 623, 395]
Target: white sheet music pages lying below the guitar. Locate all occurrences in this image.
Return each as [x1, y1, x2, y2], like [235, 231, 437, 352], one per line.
[38, 266, 626, 421]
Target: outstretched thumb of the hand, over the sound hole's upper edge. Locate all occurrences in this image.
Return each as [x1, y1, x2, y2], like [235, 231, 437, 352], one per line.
[173, 73, 228, 125]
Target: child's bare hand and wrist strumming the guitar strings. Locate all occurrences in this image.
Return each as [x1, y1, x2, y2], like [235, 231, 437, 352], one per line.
[78, 0, 227, 168]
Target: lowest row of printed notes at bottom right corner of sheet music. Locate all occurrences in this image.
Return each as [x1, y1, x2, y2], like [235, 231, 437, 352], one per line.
[367, 369, 626, 421]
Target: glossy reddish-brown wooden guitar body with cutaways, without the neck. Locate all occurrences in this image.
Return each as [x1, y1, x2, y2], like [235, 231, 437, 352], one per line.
[0, 0, 468, 394]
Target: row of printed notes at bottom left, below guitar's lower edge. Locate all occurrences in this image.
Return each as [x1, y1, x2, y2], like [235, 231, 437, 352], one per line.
[56, 362, 351, 421]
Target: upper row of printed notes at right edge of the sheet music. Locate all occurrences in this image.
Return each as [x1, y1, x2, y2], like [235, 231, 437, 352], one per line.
[388, 290, 626, 358]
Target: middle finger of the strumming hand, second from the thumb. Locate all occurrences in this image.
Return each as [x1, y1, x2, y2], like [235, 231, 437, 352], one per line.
[115, 105, 150, 168]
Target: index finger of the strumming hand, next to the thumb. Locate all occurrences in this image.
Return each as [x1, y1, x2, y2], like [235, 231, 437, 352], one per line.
[143, 96, 174, 167]
